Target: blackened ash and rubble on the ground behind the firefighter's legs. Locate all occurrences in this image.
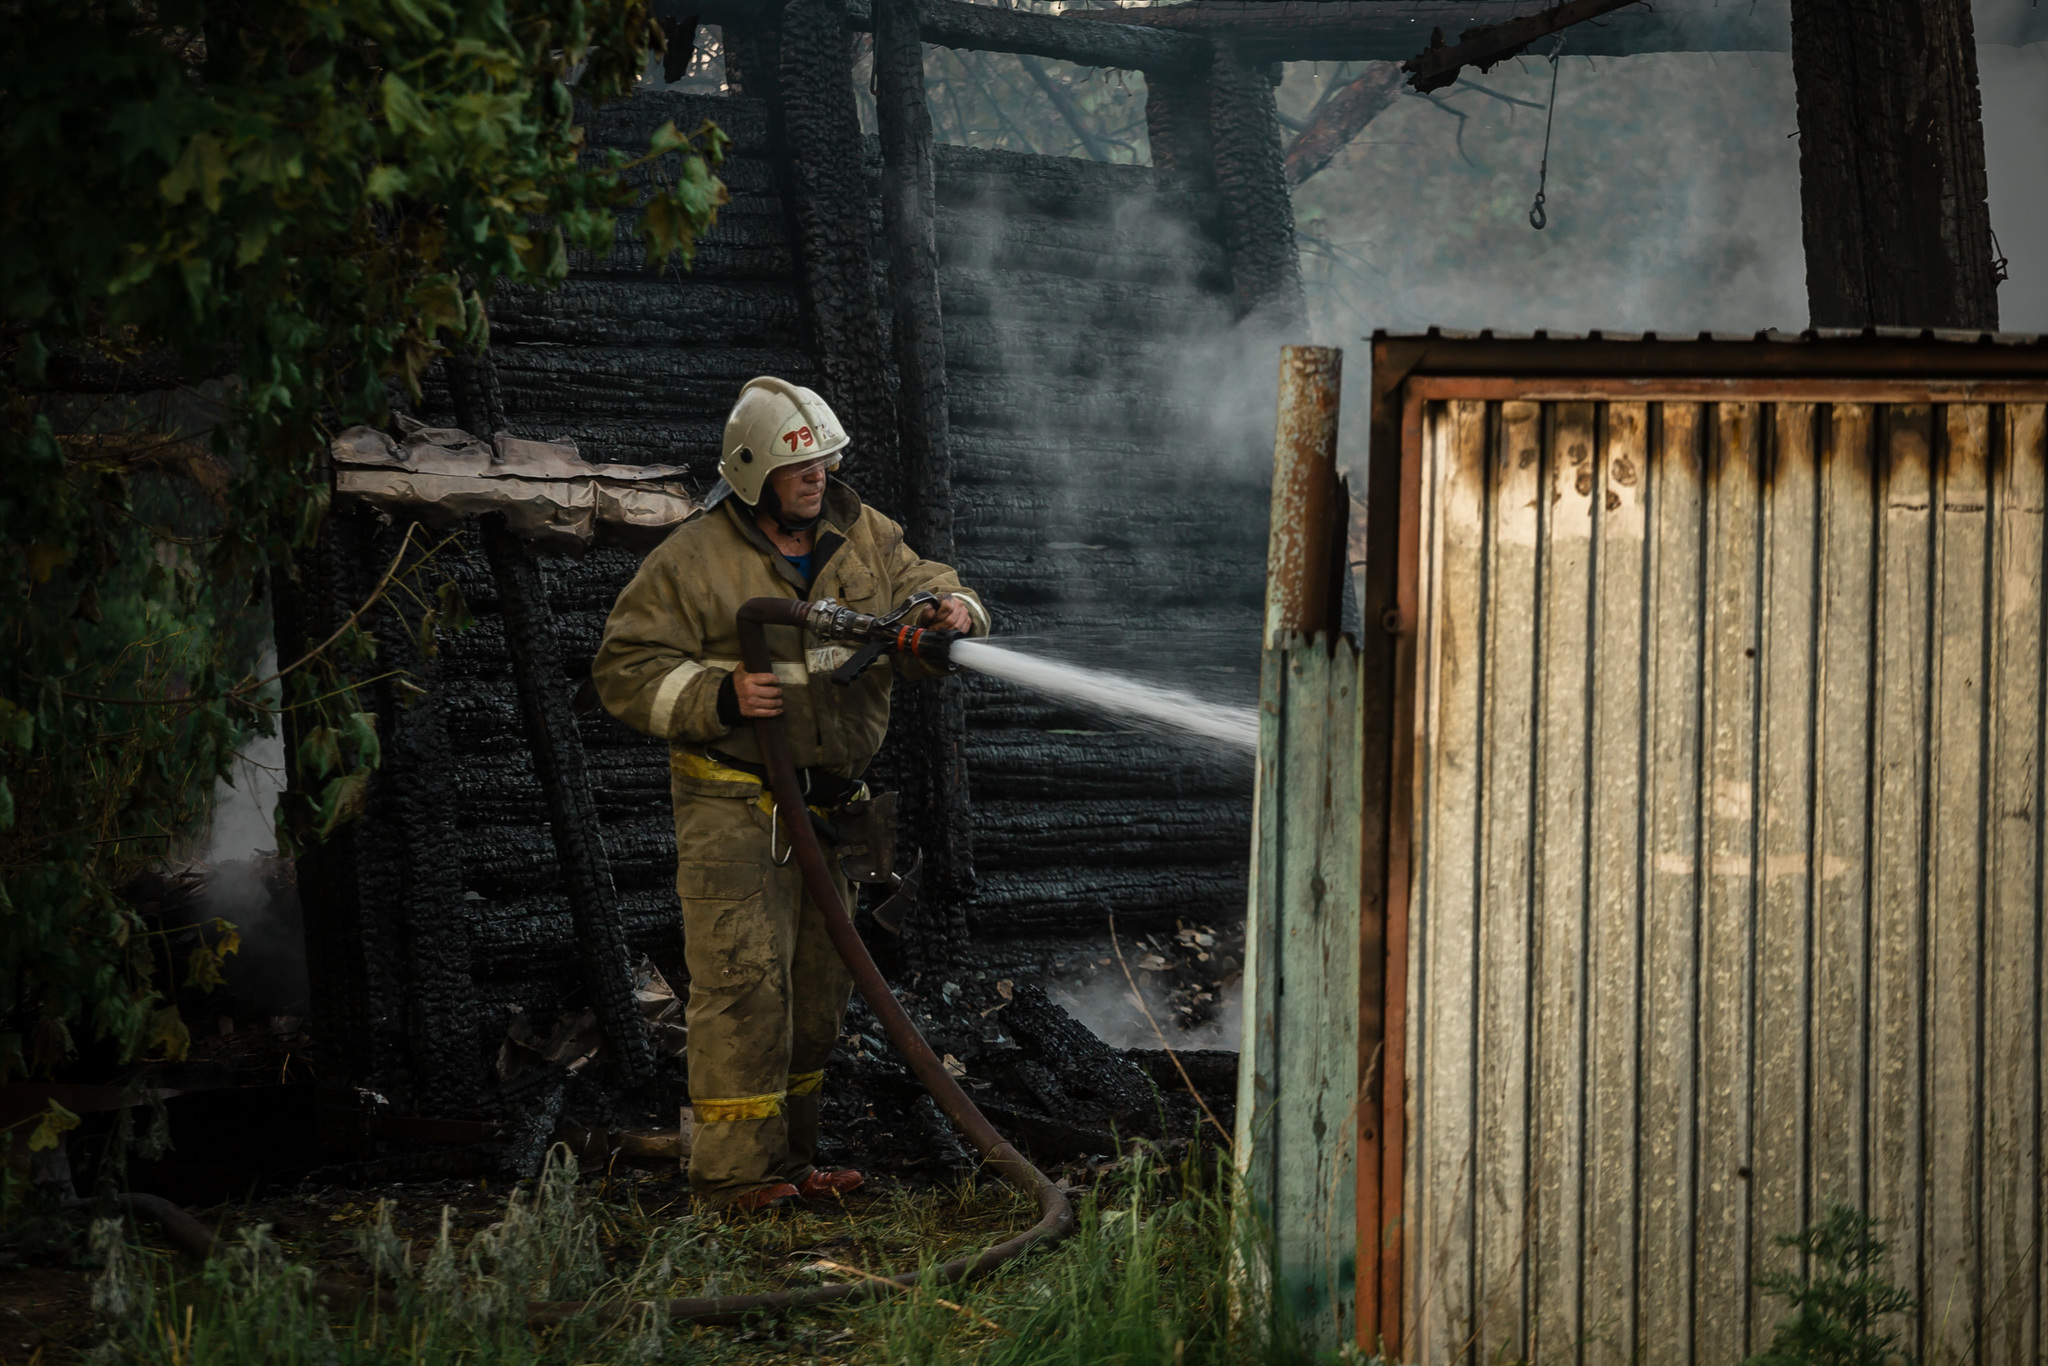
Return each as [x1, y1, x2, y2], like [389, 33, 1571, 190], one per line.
[96, 858, 1243, 1204]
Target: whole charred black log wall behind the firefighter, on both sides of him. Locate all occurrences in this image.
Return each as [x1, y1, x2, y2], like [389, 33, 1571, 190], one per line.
[309, 69, 1266, 1112]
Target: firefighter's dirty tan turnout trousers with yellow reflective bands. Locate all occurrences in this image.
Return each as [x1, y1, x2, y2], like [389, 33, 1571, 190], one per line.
[672, 756, 852, 1202]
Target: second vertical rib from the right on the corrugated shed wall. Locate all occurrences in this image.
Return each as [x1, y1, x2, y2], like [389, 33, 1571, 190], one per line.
[1921, 403, 1991, 1360]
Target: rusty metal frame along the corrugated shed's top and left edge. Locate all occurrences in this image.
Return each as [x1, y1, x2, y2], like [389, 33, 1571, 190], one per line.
[1358, 334, 2048, 1360]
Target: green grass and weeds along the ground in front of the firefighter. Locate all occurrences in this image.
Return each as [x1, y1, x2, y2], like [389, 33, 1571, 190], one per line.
[72, 1157, 1335, 1366]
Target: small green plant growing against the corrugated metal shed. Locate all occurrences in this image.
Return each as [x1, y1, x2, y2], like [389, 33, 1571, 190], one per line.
[1747, 1204, 1915, 1366]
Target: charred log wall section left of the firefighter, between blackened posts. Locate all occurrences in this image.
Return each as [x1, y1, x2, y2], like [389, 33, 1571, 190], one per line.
[428, 92, 815, 1042]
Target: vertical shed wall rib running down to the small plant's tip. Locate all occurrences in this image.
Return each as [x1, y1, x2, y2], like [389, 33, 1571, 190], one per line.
[1808, 403, 1878, 1212]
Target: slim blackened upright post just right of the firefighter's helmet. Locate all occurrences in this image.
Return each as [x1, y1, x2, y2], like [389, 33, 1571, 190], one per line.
[874, 0, 975, 956]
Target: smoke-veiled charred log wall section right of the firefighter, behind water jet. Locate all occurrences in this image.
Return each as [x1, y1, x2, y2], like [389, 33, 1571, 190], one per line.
[936, 147, 1270, 938]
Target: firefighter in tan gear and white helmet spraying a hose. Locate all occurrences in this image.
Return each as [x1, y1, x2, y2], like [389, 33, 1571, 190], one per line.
[592, 377, 989, 1210]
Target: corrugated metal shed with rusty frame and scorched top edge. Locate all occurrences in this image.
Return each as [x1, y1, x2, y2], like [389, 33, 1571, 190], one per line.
[1255, 334, 2048, 1362]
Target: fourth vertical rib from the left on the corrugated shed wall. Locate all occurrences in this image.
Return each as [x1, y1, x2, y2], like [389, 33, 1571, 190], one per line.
[1581, 403, 1651, 1366]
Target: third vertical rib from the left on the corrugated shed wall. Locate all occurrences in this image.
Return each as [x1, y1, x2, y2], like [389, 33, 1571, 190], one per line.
[1530, 403, 1597, 1360]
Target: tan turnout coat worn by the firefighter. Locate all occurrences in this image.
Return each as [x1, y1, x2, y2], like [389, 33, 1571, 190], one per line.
[590, 479, 989, 778]
